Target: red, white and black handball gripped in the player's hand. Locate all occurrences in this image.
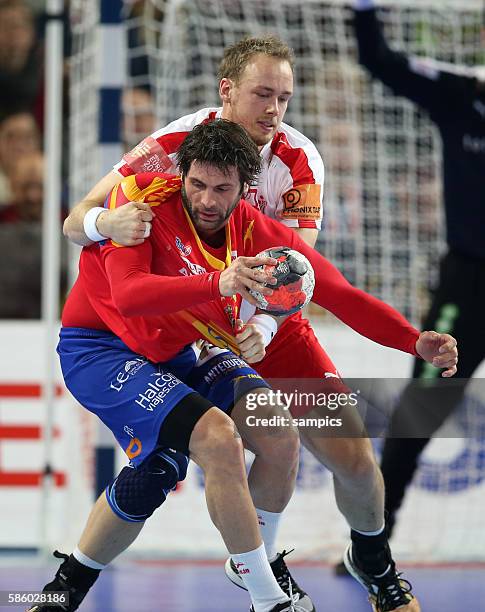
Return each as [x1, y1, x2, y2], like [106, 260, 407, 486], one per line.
[249, 247, 315, 317]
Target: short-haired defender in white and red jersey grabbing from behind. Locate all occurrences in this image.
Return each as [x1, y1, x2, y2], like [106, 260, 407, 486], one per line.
[56, 36, 458, 610]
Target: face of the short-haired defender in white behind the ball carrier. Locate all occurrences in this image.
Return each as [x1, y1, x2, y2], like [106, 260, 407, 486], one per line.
[220, 54, 293, 147]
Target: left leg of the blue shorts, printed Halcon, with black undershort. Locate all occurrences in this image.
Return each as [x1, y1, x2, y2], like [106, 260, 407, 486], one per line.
[58, 328, 208, 466]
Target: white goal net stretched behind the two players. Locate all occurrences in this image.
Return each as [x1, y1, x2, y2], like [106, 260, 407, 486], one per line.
[137, 0, 481, 323]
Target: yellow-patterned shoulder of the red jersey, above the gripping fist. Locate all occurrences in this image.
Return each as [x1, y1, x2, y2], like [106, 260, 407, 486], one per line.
[105, 172, 182, 209]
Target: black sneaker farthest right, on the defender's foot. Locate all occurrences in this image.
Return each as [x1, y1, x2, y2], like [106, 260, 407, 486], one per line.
[344, 544, 421, 612]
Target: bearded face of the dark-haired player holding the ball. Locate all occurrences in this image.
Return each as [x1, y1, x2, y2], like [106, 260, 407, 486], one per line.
[181, 161, 242, 234]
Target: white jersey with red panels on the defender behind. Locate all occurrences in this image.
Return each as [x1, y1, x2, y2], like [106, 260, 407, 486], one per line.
[114, 108, 325, 229]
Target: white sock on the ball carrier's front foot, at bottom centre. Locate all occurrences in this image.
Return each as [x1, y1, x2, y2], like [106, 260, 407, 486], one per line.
[231, 544, 288, 612]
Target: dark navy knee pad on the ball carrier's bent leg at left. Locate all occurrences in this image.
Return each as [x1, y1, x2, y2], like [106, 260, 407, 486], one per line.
[105, 448, 189, 523]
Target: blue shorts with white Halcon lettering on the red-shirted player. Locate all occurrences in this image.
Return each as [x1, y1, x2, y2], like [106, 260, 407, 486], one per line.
[57, 327, 268, 466]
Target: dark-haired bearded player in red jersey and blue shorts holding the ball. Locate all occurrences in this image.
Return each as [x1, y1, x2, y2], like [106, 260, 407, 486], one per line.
[27, 121, 456, 612]
